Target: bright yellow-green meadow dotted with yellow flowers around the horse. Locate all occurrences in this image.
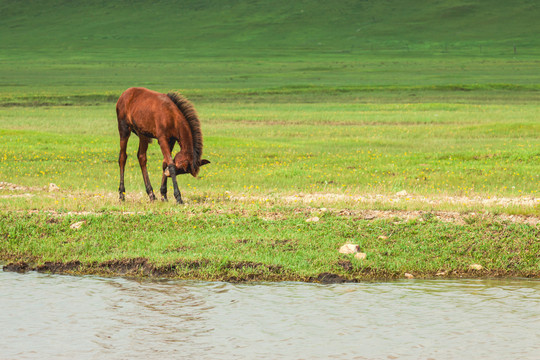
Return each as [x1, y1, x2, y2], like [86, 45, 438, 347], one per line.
[0, 102, 540, 202]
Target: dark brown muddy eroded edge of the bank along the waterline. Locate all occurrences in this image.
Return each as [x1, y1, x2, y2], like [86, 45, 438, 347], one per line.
[3, 258, 540, 284]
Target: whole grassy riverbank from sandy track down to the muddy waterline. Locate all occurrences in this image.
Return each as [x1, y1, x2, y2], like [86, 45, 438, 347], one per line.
[0, 194, 540, 283]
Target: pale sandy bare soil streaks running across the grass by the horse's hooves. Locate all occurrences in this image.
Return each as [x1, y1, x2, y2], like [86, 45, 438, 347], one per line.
[0, 182, 540, 225]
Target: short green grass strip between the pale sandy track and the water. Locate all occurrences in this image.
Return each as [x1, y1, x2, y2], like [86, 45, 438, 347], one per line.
[0, 210, 540, 280]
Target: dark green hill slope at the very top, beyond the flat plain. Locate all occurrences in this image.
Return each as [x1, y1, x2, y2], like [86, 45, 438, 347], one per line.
[4, 0, 540, 55]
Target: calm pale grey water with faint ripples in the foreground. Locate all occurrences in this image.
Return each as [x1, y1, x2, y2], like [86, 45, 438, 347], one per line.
[0, 272, 540, 360]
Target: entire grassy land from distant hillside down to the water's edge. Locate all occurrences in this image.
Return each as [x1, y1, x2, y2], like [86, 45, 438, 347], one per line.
[0, 1, 540, 281]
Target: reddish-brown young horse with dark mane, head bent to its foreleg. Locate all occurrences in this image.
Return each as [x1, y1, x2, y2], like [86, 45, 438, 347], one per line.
[116, 88, 210, 204]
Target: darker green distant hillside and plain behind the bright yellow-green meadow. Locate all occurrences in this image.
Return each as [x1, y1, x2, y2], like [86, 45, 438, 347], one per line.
[0, 0, 540, 98]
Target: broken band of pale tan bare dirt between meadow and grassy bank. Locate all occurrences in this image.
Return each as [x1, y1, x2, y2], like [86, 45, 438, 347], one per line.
[0, 182, 540, 226]
